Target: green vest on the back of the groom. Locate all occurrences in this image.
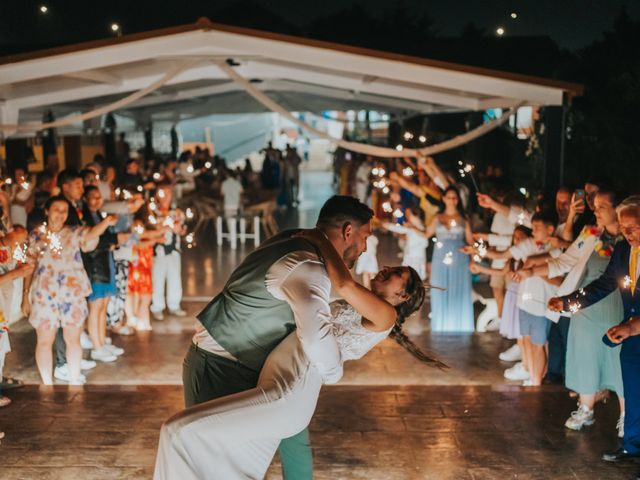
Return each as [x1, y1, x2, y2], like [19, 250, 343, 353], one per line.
[198, 231, 316, 371]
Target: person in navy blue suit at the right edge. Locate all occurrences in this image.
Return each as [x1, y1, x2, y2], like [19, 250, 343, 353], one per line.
[549, 195, 640, 462]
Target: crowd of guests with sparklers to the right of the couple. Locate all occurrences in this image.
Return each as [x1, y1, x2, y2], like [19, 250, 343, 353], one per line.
[336, 152, 640, 461]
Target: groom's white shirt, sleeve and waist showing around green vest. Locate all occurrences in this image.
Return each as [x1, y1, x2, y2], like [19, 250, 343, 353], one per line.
[193, 251, 342, 383]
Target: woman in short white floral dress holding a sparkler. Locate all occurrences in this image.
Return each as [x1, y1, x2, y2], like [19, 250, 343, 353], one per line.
[23, 196, 117, 385]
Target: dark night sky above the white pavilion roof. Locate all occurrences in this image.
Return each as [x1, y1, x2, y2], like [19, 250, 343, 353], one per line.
[0, 0, 640, 53]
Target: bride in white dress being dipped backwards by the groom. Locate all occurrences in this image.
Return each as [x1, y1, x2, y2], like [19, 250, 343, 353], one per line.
[154, 229, 446, 480]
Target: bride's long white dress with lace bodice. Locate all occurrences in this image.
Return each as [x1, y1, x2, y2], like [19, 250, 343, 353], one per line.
[154, 300, 389, 480]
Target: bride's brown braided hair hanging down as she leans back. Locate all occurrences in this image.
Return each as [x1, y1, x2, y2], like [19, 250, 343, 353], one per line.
[389, 267, 449, 370]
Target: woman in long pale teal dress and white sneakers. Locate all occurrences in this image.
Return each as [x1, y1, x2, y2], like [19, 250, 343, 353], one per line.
[518, 187, 624, 437]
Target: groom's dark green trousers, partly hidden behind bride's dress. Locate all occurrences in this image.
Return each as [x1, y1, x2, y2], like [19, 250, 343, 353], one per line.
[182, 344, 313, 480]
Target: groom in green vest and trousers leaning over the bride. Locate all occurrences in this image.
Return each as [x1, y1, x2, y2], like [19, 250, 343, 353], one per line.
[182, 195, 373, 480]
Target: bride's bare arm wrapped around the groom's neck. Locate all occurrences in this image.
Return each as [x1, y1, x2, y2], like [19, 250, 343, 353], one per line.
[297, 230, 397, 332]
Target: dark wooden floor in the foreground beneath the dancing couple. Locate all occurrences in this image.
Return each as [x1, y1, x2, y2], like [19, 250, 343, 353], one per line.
[0, 385, 640, 480]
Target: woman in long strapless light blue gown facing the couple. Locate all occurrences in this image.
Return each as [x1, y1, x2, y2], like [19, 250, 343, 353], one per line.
[416, 187, 474, 333]
